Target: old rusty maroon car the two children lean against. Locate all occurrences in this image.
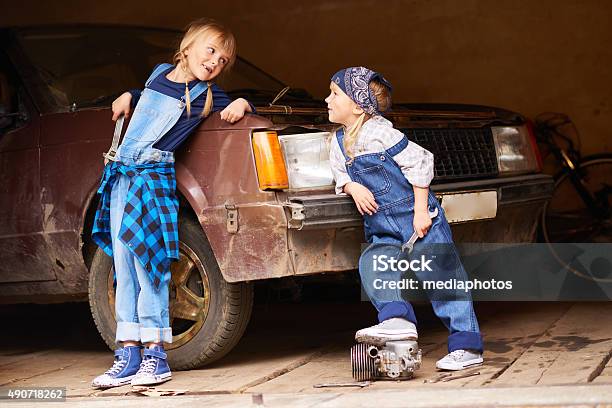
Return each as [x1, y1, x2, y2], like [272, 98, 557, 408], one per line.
[0, 26, 552, 369]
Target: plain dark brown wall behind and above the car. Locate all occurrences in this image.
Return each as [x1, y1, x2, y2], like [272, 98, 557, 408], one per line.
[0, 0, 612, 153]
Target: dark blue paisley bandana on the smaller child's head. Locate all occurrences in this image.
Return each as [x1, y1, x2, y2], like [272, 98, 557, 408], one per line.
[332, 67, 393, 115]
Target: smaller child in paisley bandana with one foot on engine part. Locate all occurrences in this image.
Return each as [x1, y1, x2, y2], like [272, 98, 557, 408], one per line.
[325, 67, 483, 370]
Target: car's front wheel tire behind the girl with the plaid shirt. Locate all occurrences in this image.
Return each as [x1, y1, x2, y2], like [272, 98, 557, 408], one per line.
[89, 217, 253, 370]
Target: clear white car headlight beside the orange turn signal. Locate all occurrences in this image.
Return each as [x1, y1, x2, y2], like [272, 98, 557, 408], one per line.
[278, 132, 334, 189]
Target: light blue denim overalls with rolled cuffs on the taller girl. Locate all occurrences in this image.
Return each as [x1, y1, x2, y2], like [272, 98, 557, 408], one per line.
[110, 64, 207, 343]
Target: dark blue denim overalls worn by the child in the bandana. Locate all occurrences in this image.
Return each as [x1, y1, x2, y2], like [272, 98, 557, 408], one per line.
[336, 129, 482, 352]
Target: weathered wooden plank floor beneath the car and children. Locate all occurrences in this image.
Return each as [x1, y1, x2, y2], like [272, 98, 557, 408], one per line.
[0, 302, 612, 396]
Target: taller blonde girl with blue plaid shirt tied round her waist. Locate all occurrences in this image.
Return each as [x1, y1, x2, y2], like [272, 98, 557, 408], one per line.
[92, 20, 253, 388]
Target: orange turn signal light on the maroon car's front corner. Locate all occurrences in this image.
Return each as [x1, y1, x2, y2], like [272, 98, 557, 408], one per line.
[253, 131, 289, 190]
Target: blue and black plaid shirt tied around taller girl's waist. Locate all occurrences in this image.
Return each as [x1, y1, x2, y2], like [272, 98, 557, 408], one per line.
[92, 162, 179, 289]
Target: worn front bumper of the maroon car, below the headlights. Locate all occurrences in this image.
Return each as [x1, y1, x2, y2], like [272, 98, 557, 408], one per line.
[284, 175, 554, 275]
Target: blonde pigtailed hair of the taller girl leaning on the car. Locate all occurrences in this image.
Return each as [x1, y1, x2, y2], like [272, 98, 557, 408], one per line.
[172, 18, 236, 116]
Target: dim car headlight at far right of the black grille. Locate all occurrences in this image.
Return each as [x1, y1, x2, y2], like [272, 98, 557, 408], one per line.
[491, 126, 540, 175]
